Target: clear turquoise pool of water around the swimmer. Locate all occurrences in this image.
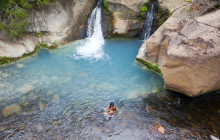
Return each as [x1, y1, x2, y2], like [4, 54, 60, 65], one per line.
[0, 39, 220, 139]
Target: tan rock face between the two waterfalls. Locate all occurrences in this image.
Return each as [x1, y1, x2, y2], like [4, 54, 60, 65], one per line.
[106, 0, 148, 37]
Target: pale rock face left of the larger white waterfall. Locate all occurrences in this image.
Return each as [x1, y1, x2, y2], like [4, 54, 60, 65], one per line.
[0, 0, 96, 57]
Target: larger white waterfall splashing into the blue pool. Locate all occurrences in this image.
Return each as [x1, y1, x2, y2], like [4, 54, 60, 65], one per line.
[74, 0, 105, 59]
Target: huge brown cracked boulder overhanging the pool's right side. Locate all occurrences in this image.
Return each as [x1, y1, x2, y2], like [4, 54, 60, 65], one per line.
[137, 3, 220, 96]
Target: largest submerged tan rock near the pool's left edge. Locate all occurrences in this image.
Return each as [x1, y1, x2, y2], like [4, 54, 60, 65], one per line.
[3, 104, 21, 117]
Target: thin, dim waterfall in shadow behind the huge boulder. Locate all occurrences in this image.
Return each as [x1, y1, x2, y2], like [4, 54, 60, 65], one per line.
[141, 4, 155, 40]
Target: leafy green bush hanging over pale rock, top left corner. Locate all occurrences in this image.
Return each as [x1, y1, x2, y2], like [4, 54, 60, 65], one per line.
[0, 0, 50, 37]
